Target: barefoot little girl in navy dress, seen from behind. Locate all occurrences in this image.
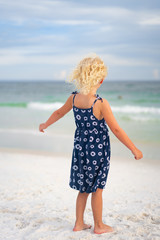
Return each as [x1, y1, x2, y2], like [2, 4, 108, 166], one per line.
[39, 56, 143, 234]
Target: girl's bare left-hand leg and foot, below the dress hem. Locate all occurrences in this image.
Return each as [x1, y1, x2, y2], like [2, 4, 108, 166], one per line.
[73, 192, 91, 231]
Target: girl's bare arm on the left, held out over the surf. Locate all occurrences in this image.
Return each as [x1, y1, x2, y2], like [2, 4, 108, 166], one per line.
[39, 95, 73, 132]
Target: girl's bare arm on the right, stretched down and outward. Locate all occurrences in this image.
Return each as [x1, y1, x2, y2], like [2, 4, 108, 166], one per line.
[101, 98, 143, 160]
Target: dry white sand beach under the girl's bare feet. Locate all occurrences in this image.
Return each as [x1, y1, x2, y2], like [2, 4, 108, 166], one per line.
[0, 150, 160, 240]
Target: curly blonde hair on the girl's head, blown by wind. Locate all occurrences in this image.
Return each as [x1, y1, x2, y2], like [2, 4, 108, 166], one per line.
[68, 54, 107, 95]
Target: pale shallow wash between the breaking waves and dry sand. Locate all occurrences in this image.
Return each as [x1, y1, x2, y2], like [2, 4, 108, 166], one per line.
[0, 126, 160, 164]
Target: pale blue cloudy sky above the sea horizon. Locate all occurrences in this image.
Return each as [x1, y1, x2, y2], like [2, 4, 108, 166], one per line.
[0, 0, 160, 81]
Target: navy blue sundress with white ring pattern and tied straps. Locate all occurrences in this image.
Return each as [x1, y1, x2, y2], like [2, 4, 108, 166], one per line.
[69, 91, 111, 193]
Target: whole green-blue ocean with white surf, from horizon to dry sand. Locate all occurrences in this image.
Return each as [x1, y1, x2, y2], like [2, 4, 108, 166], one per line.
[0, 80, 160, 159]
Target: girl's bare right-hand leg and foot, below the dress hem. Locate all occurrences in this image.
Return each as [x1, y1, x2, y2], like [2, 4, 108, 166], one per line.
[91, 188, 114, 234]
